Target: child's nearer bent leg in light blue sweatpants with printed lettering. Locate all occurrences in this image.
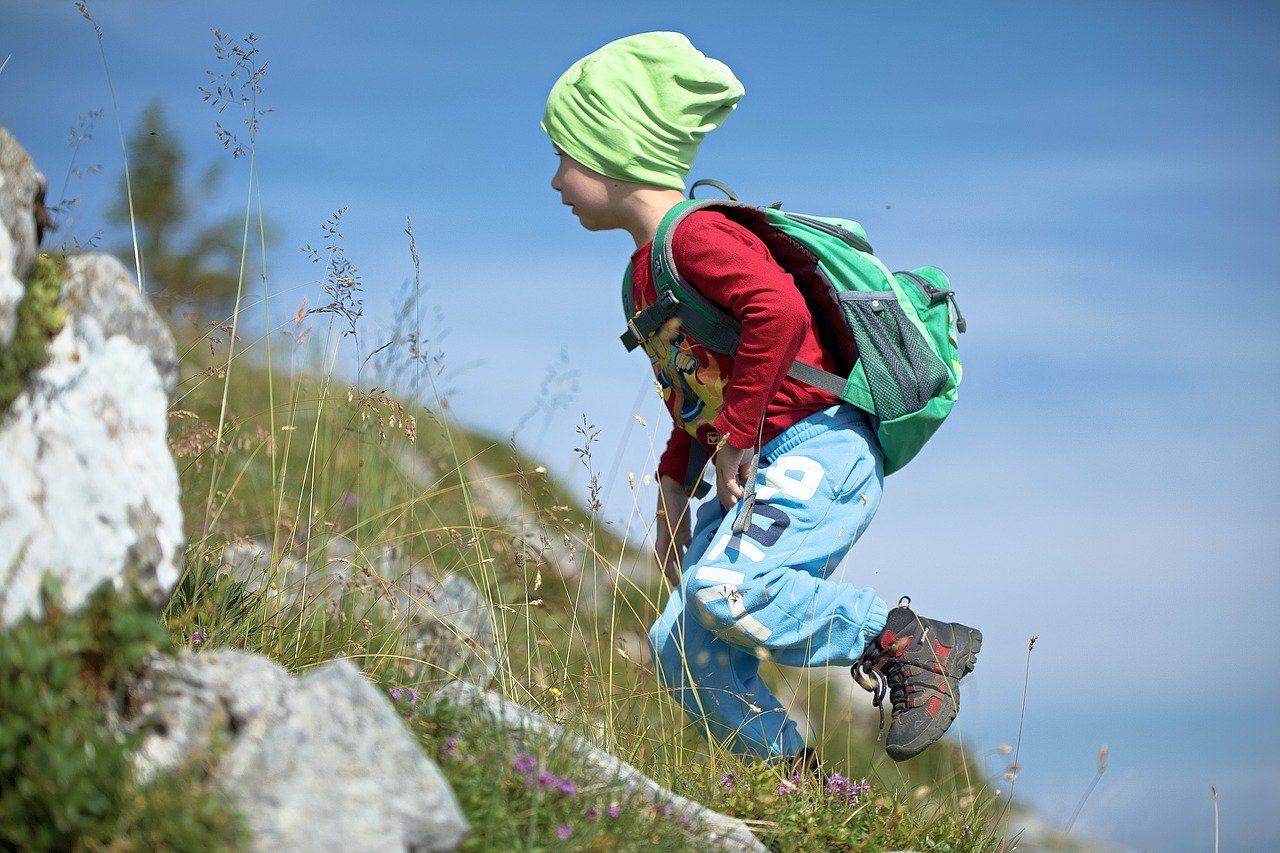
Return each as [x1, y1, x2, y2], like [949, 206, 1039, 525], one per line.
[682, 409, 888, 666]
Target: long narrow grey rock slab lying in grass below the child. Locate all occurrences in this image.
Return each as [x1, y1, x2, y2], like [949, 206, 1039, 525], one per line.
[430, 681, 768, 853]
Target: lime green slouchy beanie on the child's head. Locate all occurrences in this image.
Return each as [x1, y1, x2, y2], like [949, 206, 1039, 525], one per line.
[543, 32, 744, 190]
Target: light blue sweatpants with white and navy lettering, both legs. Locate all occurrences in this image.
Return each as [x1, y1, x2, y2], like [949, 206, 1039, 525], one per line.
[649, 405, 888, 757]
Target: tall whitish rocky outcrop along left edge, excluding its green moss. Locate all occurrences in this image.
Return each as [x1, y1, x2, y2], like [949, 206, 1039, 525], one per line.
[0, 128, 183, 625]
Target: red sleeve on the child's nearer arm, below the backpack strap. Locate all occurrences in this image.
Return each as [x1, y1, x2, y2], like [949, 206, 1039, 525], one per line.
[672, 214, 809, 448]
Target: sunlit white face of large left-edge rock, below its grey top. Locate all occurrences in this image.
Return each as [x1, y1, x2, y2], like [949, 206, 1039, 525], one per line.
[0, 282, 184, 625]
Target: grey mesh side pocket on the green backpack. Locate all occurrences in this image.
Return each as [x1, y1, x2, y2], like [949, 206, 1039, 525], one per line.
[840, 291, 948, 420]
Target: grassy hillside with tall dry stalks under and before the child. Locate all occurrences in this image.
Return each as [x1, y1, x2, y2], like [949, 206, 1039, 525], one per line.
[154, 318, 1000, 850]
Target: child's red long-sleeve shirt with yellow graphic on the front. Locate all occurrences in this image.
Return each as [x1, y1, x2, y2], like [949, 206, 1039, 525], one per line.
[631, 210, 840, 482]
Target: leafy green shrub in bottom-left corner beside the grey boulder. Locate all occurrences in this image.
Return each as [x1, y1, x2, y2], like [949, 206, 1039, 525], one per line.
[0, 585, 243, 850]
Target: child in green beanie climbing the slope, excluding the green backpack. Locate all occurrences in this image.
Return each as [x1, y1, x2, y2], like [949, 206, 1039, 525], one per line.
[543, 32, 982, 767]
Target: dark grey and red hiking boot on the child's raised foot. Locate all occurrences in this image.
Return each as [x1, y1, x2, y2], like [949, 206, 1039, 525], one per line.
[851, 596, 982, 761]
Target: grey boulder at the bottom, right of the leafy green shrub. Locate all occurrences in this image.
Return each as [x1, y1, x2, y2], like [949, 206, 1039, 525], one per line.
[136, 651, 470, 852]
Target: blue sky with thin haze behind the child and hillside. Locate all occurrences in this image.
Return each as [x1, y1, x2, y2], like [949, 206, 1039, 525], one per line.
[0, 0, 1280, 849]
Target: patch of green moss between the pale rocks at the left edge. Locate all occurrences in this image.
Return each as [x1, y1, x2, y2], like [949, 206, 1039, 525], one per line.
[0, 255, 67, 418]
